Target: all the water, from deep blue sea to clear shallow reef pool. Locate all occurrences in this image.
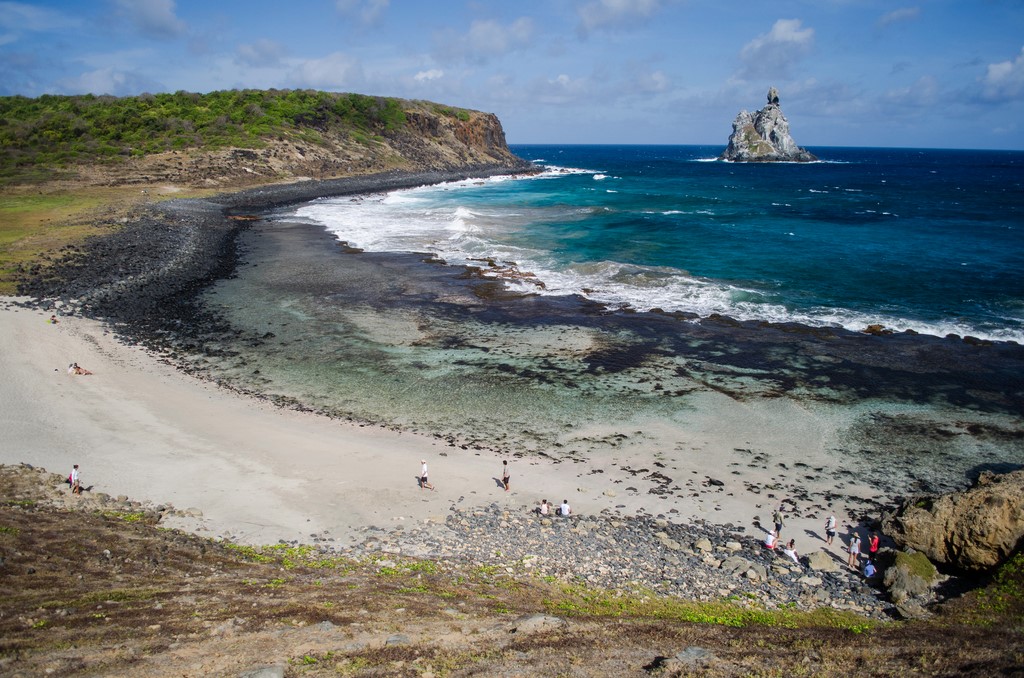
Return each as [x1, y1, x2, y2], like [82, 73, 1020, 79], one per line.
[195, 145, 1024, 496]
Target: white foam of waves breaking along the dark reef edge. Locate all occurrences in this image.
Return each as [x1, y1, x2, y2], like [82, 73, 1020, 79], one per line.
[295, 175, 1024, 343]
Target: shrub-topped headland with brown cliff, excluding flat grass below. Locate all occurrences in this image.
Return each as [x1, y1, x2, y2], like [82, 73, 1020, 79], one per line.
[0, 90, 521, 188]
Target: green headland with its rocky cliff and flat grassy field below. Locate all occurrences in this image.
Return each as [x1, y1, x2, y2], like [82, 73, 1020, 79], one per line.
[0, 90, 528, 294]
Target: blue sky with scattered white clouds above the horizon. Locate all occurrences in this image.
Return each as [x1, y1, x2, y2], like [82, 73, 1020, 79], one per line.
[0, 0, 1024, 150]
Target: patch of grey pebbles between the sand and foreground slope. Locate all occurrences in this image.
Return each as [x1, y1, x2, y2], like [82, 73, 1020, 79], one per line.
[333, 504, 893, 619]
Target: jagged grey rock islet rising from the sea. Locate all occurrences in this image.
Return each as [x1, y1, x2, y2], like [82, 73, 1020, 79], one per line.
[720, 87, 817, 163]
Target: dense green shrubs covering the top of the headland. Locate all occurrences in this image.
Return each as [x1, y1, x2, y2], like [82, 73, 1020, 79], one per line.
[0, 89, 407, 184]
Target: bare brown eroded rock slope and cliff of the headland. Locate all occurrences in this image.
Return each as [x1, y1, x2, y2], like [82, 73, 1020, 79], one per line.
[70, 102, 528, 188]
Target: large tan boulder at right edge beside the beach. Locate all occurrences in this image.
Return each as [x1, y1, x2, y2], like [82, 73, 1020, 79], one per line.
[882, 470, 1024, 571]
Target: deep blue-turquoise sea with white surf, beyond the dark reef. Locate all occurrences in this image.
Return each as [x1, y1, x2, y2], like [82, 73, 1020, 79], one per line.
[296, 145, 1024, 342]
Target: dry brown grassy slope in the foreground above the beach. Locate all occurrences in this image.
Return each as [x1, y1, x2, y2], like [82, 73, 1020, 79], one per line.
[0, 465, 1021, 676]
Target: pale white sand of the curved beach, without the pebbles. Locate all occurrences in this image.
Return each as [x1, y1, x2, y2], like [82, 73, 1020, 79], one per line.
[0, 299, 869, 554]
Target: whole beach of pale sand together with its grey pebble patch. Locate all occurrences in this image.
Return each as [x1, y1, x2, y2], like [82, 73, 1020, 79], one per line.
[0, 298, 890, 619]
